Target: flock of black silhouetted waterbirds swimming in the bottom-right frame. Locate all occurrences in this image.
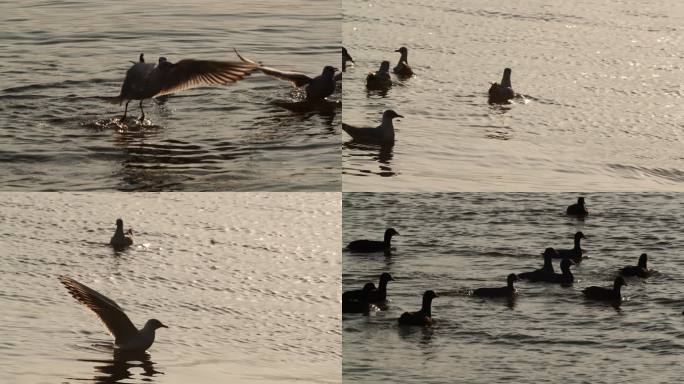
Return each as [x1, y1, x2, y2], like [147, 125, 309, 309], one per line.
[342, 197, 653, 325]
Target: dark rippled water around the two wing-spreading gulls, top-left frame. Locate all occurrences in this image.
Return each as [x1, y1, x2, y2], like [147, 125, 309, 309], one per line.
[0, 0, 341, 191]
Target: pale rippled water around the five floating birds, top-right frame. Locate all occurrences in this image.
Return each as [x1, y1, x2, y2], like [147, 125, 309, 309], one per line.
[343, 0, 684, 191]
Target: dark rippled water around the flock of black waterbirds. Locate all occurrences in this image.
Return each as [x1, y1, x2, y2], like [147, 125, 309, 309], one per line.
[342, 193, 684, 383]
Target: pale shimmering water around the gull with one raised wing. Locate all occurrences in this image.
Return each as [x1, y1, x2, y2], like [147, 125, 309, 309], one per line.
[0, 193, 341, 383]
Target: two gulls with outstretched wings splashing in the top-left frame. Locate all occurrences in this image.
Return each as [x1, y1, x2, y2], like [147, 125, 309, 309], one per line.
[111, 50, 342, 122]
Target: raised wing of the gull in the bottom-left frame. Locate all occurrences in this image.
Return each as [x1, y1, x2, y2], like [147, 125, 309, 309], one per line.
[59, 276, 138, 344]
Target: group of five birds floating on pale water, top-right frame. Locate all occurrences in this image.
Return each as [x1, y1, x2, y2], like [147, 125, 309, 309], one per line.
[342, 47, 518, 146]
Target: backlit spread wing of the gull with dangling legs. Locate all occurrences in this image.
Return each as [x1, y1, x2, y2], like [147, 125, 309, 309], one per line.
[150, 59, 257, 96]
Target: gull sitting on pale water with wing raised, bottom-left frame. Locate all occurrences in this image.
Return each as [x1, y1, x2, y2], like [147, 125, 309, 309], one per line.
[59, 276, 168, 351]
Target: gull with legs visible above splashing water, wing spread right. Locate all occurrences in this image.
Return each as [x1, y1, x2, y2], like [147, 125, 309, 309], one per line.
[108, 53, 256, 122]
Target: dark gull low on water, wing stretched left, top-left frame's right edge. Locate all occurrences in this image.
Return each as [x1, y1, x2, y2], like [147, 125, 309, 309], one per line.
[235, 49, 342, 101]
